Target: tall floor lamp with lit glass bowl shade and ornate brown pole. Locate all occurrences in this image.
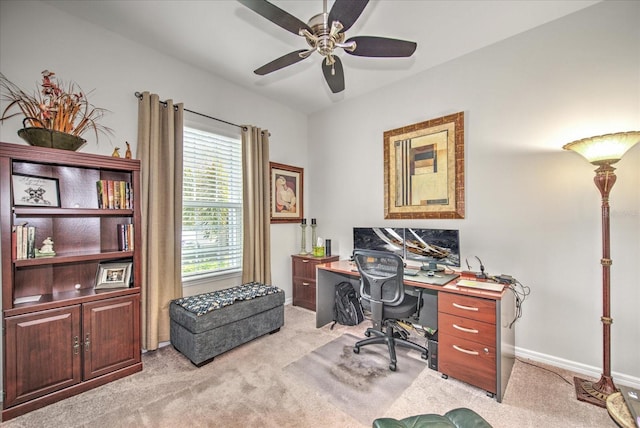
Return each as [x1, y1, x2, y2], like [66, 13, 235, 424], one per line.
[562, 131, 640, 407]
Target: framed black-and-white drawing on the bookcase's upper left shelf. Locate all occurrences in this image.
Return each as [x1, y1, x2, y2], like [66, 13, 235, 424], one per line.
[11, 174, 60, 208]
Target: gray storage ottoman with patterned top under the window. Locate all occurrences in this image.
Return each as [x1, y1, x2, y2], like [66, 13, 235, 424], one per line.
[169, 283, 284, 367]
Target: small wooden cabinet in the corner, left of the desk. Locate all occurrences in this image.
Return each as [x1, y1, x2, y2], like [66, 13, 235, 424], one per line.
[291, 255, 339, 311]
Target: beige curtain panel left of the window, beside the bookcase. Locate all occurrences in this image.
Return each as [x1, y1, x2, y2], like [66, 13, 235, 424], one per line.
[137, 92, 184, 350]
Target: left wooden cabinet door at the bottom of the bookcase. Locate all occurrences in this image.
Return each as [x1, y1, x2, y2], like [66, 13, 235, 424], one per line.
[4, 305, 82, 408]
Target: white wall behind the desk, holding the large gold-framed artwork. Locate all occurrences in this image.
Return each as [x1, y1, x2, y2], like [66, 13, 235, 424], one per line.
[308, 1, 640, 385]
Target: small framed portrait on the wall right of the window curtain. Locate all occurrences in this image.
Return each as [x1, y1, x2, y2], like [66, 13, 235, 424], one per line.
[269, 162, 304, 223]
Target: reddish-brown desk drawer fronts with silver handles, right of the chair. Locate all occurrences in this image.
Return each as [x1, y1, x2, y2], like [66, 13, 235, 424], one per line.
[438, 293, 498, 394]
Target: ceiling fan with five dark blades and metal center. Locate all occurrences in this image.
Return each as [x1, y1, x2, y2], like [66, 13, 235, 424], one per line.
[238, 0, 417, 94]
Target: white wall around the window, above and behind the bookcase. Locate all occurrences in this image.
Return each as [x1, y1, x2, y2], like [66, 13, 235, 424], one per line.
[0, 0, 307, 342]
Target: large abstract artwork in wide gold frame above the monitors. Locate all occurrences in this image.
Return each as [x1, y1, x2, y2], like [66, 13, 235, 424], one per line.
[384, 112, 465, 219]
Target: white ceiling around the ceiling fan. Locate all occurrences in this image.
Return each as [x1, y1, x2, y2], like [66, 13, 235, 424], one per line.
[46, 0, 599, 113]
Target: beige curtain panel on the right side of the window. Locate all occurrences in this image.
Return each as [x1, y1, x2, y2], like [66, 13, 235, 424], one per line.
[242, 126, 271, 284]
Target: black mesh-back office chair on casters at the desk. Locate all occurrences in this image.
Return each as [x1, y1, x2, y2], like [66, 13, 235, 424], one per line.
[353, 250, 427, 371]
